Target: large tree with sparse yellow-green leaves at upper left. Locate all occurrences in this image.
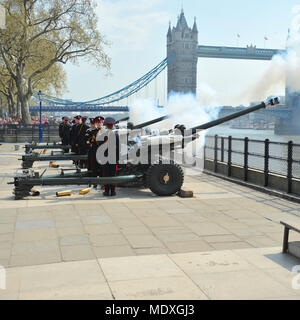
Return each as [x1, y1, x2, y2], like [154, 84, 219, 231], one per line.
[0, 0, 110, 123]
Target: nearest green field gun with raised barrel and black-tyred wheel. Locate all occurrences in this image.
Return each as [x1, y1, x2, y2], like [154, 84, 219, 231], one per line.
[10, 97, 279, 199]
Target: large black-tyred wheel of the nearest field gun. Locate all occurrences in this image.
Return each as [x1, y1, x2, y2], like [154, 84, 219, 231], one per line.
[146, 161, 184, 197]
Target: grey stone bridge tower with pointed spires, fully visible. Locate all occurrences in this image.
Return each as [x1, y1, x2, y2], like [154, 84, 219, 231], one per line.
[167, 9, 198, 94]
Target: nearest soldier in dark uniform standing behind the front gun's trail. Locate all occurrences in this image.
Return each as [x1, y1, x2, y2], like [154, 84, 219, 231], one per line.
[96, 117, 119, 197]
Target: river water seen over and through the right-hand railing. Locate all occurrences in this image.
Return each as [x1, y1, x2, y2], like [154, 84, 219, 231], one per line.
[206, 126, 300, 178]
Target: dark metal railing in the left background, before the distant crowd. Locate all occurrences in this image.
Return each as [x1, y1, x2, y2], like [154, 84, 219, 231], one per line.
[0, 124, 58, 142]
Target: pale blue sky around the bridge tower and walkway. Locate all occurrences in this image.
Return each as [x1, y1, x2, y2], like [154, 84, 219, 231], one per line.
[64, 0, 300, 105]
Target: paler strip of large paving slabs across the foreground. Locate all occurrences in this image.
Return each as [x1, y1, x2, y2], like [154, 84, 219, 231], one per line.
[0, 247, 300, 300]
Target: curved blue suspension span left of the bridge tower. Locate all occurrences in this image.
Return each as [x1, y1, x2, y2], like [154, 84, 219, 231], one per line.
[34, 55, 175, 106]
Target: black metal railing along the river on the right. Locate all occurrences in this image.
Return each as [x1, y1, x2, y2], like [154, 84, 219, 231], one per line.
[205, 135, 300, 193]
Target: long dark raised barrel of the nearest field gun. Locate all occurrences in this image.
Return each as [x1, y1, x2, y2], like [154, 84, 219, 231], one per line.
[191, 97, 279, 134]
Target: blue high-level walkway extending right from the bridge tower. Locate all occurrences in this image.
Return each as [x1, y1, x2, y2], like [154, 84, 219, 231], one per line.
[198, 45, 286, 60]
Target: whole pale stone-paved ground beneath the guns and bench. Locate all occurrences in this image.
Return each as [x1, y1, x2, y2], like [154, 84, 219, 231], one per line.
[0, 146, 300, 299]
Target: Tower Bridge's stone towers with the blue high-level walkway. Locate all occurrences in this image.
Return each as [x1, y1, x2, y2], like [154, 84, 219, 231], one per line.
[167, 9, 300, 135]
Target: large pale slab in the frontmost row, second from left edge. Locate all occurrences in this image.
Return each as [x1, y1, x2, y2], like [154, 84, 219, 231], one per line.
[20, 260, 112, 299]
